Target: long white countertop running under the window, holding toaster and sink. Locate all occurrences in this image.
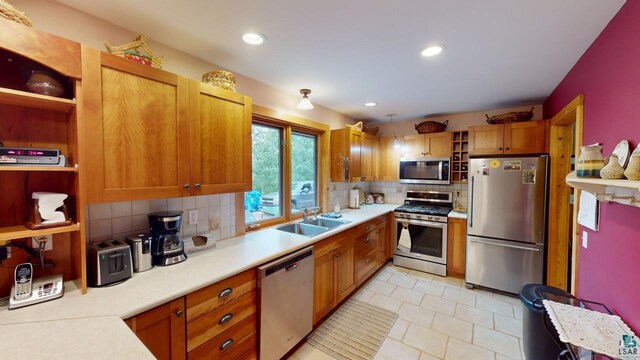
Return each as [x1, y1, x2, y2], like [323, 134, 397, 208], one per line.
[0, 204, 397, 325]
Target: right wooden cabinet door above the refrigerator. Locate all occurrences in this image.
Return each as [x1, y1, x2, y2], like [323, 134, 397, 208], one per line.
[504, 121, 545, 155]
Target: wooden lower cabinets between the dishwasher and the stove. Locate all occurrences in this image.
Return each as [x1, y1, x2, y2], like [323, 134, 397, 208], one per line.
[313, 215, 389, 325]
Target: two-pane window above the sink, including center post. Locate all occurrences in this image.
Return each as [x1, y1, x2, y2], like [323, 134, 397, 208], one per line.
[244, 119, 319, 224]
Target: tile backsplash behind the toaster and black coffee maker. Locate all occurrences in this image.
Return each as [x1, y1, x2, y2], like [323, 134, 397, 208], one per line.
[87, 194, 236, 242]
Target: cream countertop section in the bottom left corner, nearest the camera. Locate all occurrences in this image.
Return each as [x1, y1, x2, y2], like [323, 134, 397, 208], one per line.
[0, 316, 155, 360]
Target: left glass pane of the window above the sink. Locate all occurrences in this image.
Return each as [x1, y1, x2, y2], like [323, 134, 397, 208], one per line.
[244, 123, 282, 224]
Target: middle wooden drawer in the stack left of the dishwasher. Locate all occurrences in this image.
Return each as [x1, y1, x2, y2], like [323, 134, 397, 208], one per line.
[187, 290, 256, 351]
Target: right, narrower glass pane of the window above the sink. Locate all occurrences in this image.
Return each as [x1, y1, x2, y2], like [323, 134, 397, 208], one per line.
[291, 132, 318, 213]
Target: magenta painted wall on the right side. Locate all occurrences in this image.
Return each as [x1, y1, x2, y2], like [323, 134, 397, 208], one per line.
[544, 0, 640, 333]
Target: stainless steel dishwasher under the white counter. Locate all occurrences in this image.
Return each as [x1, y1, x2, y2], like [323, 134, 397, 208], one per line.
[258, 247, 313, 360]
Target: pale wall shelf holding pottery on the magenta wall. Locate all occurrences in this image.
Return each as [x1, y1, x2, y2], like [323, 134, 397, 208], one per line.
[565, 171, 640, 207]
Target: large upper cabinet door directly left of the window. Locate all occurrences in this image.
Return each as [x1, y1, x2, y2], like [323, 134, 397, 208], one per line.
[190, 81, 251, 195]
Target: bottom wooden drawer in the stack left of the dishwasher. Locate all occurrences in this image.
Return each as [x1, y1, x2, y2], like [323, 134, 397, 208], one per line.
[189, 314, 257, 360]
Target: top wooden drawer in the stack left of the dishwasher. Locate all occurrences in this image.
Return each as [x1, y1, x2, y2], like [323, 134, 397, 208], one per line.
[187, 269, 256, 322]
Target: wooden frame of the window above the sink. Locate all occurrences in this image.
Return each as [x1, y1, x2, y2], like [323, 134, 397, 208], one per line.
[236, 105, 330, 235]
